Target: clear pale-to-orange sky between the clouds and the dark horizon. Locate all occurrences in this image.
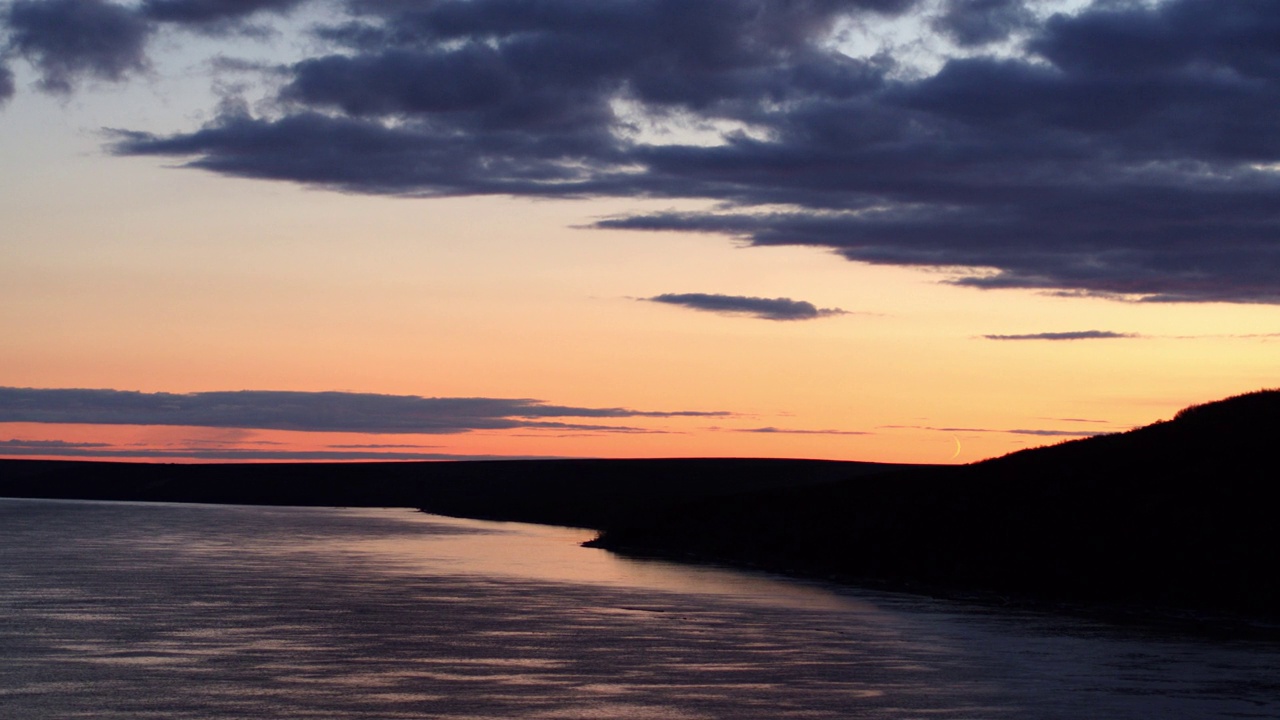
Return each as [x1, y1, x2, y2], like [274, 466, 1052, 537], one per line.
[0, 0, 1280, 462]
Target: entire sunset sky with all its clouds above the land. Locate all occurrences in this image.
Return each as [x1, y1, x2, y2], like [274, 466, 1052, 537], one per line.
[0, 0, 1280, 462]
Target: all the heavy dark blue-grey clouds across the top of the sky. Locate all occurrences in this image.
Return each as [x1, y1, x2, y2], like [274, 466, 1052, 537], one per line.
[0, 0, 1280, 304]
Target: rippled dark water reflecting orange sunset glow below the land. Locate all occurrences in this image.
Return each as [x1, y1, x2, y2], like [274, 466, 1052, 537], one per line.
[0, 500, 1280, 720]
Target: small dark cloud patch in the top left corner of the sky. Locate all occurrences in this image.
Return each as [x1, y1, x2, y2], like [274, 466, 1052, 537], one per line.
[4, 0, 151, 92]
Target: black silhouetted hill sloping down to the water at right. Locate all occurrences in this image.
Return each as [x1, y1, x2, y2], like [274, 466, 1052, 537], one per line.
[595, 391, 1280, 616]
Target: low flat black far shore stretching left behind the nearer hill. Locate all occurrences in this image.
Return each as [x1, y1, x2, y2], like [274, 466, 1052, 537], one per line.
[0, 459, 902, 529]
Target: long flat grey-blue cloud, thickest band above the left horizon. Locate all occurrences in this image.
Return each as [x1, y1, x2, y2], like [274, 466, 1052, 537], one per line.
[0, 387, 727, 434]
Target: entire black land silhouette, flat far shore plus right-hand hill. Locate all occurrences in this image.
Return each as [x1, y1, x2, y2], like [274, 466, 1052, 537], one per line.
[0, 391, 1280, 621]
